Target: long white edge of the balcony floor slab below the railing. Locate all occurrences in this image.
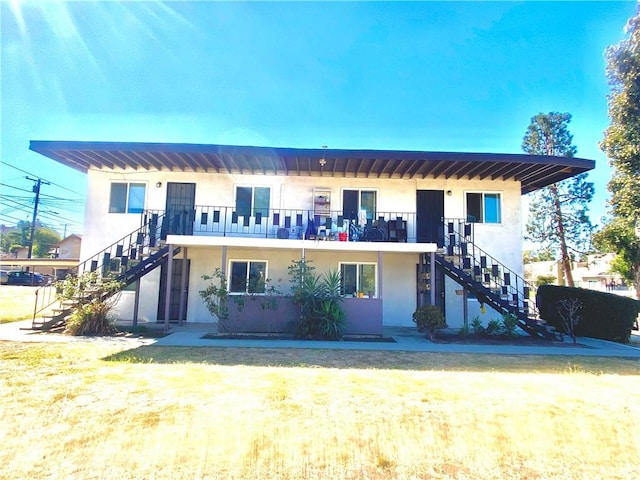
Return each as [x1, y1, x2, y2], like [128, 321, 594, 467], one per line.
[166, 235, 438, 253]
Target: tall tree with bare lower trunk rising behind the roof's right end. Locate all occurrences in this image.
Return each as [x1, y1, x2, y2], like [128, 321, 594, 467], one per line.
[522, 112, 594, 287]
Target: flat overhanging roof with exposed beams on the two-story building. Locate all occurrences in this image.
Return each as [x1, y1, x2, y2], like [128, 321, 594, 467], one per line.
[29, 140, 595, 193]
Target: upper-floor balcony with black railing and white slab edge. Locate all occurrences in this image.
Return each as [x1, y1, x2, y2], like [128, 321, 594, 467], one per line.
[143, 205, 435, 252]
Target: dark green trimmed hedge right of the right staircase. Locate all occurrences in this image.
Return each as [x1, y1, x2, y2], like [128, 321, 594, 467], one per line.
[536, 285, 640, 343]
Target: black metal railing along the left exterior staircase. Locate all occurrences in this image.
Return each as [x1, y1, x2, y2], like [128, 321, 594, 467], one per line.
[32, 213, 163, 328]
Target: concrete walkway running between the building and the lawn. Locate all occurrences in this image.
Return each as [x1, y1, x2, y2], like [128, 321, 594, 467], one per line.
[0, 320, 640, 360]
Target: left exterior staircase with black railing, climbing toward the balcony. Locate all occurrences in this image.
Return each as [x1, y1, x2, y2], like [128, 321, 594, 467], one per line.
[31, 213, 174, 330]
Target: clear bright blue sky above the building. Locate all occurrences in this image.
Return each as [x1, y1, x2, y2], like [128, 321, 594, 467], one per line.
[0, 0, 636, 234]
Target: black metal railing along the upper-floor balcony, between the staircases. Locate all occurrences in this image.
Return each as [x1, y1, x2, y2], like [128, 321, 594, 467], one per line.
[145, 205, 416, 242]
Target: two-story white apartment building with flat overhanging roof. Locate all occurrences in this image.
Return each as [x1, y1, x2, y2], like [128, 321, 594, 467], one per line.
[30, 141, 594, 333]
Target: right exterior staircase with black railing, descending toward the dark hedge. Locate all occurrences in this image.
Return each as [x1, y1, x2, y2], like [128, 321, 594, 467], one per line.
[435, 219, 558, 339]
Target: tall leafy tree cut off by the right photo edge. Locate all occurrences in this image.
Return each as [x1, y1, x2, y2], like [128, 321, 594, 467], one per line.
[594, 7, 640, 296]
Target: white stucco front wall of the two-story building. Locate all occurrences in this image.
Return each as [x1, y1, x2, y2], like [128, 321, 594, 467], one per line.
[81, 165, 523, 326]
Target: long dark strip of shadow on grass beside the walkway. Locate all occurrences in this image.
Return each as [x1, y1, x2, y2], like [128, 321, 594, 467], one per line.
[104, 345, 640, 375]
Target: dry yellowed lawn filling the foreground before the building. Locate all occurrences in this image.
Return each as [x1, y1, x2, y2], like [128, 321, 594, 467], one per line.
[0, 342, 640, 480]
